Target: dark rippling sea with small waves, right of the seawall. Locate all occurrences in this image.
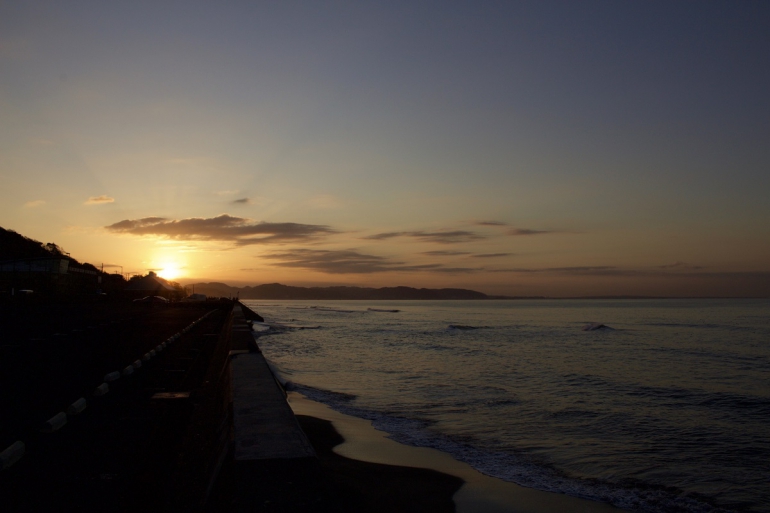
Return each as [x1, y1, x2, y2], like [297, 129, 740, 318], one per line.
[245, 299, 770, 512]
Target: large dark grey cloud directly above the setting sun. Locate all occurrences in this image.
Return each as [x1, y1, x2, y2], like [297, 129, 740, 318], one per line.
[105, 214, 338, 246]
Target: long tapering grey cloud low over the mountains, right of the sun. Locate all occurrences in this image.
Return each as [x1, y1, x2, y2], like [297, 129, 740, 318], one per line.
[263, 249, 479, 274]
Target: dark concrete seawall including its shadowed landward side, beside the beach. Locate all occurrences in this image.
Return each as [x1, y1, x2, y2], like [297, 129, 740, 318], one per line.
[170, 303, 326, 512]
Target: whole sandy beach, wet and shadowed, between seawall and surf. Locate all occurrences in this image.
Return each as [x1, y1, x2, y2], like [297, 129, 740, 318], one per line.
[288, 392, 621, 513]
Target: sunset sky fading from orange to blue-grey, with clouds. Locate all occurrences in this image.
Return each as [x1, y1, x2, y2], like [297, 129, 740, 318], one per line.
[0, 0, 770, 297]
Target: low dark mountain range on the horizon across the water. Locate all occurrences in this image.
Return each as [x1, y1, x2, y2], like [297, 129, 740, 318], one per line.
[187, 283, 492, 300]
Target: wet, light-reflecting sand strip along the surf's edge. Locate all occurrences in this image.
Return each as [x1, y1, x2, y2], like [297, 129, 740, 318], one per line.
[287, 392, 623, 513]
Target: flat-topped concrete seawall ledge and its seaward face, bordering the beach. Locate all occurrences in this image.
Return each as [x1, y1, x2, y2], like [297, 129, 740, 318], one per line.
[212, 304, 327, 512]
